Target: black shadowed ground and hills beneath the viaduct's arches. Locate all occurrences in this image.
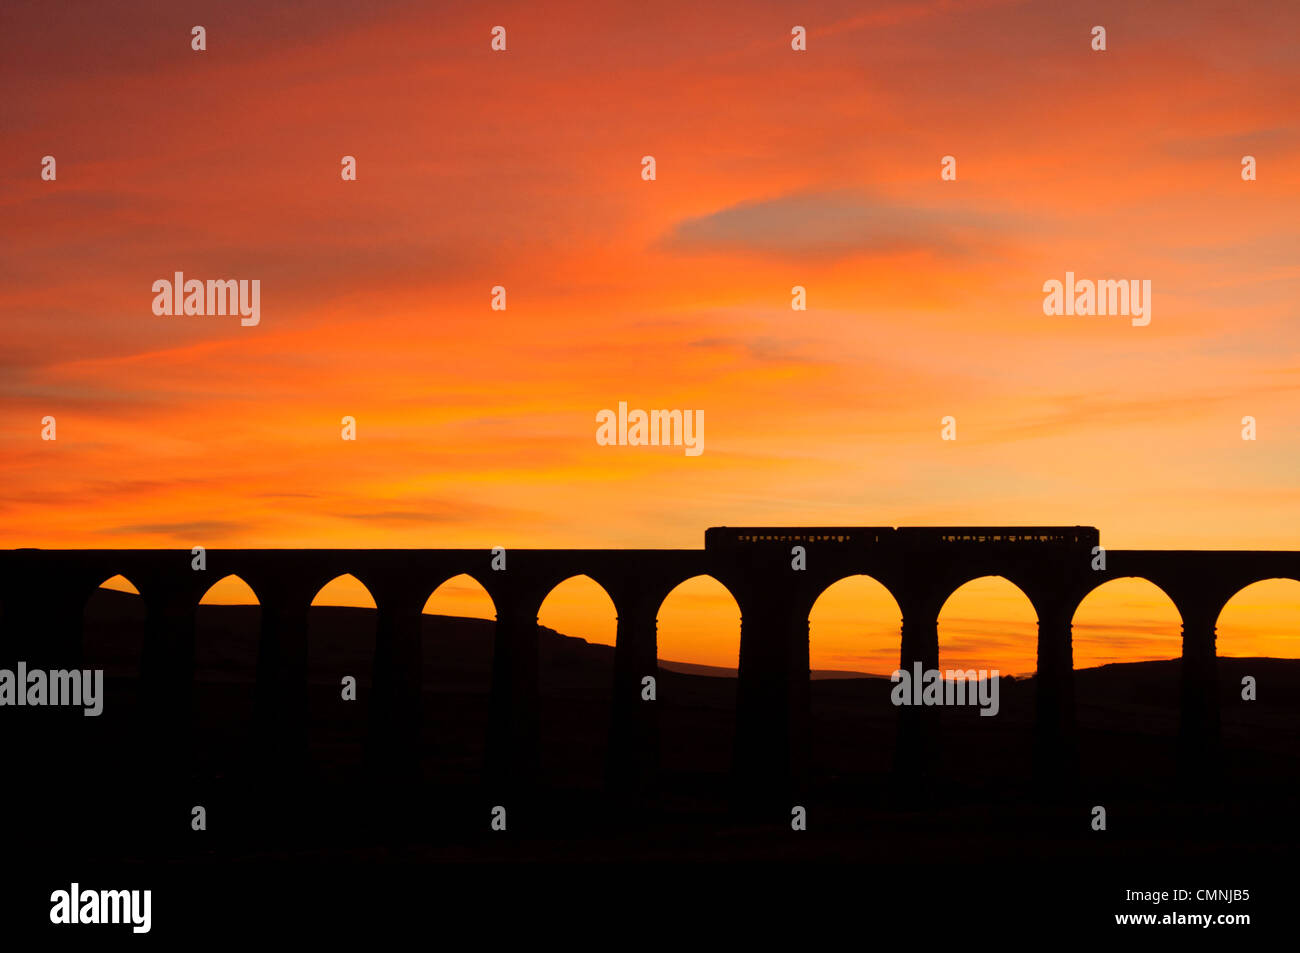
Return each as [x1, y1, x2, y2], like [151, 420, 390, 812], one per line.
[0, 592, 1300, 941]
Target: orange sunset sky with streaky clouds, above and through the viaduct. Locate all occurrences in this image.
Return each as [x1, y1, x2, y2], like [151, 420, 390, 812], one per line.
[0, 0, 1300, 671]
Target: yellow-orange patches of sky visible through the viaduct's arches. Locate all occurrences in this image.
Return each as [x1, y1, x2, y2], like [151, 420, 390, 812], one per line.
[180, 575, 1300, 675]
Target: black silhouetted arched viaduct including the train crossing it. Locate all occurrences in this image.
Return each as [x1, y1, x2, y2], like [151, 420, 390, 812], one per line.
[0, 527, 1300, 789]
